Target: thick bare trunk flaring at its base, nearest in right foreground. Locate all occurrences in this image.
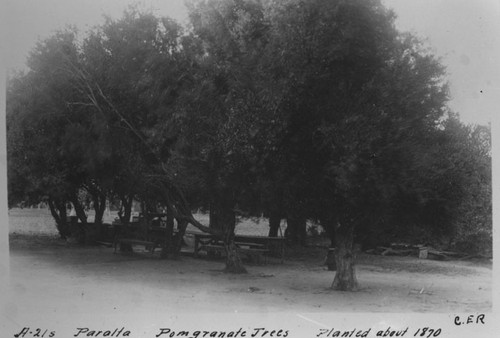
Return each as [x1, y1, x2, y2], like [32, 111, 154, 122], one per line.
[332, 223, 358, 291]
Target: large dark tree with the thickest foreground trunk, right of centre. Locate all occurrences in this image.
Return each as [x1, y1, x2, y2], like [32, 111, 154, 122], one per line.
[260, 0, 447, 290]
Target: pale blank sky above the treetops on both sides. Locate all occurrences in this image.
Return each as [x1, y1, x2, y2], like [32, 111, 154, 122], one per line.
[0, 0, 500, 124]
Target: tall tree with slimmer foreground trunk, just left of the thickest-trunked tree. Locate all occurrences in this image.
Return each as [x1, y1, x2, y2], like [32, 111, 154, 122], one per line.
[179, 0, 274, 272]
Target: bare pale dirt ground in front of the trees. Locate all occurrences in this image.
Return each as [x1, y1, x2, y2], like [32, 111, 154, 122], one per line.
[8, 234, 492, 315]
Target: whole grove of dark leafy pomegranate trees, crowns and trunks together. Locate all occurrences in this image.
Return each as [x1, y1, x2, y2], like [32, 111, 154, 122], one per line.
[7, 0, 492, 290]
